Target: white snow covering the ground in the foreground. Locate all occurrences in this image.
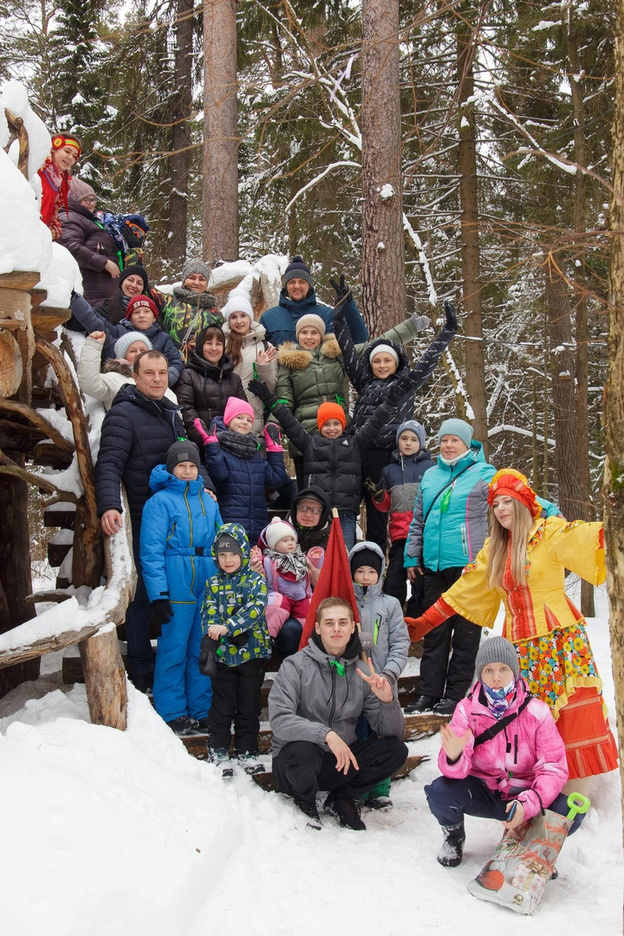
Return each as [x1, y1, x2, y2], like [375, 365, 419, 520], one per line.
[0, 593, 622, 936]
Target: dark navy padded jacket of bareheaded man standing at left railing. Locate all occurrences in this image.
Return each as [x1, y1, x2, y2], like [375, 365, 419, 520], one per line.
[95, 384, 185, 539]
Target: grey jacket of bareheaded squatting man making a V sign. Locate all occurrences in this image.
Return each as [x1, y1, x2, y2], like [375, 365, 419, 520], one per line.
[269, 641, 405, 757]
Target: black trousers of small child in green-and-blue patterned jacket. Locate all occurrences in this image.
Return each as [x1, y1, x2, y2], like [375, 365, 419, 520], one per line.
[208, 660, 267, 755]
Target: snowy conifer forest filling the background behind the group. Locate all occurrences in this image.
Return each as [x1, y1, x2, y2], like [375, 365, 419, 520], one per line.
[0, 0, 615, 532]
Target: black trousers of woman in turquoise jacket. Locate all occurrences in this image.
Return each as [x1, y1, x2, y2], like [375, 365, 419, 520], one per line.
[418, 566, 481, 701]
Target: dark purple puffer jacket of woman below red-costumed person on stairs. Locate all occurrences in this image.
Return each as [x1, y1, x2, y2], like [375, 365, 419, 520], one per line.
[57, 194, 119, 305]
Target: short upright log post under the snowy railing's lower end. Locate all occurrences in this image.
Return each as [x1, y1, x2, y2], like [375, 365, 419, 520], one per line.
[78, 625, 128, 731]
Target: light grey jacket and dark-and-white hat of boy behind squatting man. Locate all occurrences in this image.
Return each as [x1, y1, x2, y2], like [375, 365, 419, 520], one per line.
[349, 542, 410, 683]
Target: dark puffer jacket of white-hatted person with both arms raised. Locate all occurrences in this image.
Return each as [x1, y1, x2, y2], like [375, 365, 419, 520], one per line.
[335, 320, 457, 451]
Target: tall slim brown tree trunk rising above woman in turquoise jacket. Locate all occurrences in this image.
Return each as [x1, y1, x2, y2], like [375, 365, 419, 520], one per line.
[457, 9, 488, 457]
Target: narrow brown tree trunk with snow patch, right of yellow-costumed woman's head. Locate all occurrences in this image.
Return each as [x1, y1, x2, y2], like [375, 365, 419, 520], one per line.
[545, 262, 581, 520]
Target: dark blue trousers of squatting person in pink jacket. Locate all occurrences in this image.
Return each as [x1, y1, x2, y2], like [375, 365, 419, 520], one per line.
[425, 774, 584, 835]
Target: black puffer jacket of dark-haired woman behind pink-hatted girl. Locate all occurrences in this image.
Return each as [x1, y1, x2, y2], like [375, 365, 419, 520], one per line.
[175, 351, 247, 452]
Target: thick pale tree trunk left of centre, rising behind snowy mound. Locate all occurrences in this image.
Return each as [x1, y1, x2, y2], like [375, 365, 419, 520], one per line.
[203, 0, 239, 261]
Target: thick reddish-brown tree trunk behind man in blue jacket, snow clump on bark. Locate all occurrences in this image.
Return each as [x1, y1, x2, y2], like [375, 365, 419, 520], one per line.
[361, 0, 405, 335]
